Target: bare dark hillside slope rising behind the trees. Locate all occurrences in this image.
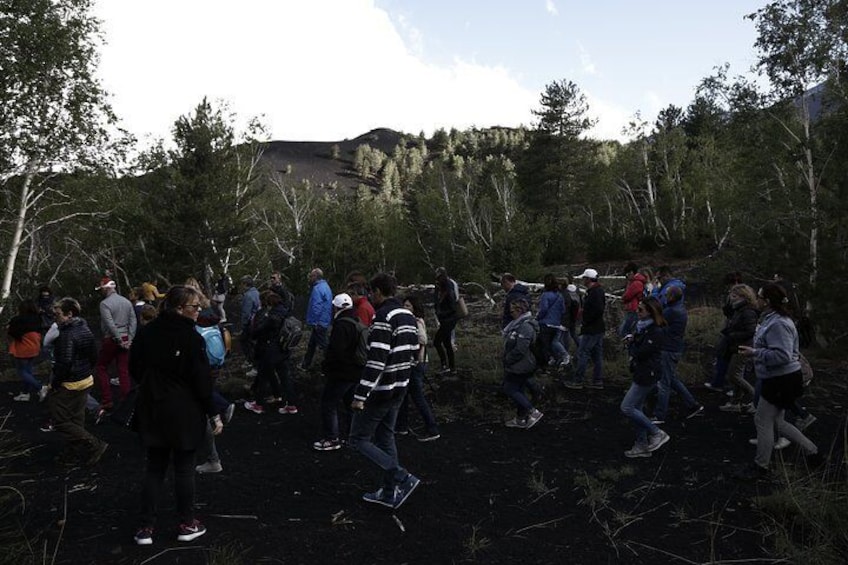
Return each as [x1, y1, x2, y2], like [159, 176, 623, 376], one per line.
[264, 128, 403, 188]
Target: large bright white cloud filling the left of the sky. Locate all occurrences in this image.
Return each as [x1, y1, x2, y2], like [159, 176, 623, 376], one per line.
[98, 0, 537, 141]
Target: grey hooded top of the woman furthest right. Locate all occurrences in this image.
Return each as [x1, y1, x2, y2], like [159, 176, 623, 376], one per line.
[754, 311, 801, 379]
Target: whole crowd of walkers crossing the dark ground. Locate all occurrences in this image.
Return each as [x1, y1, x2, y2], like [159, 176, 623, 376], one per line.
[8, 264, 821, 545]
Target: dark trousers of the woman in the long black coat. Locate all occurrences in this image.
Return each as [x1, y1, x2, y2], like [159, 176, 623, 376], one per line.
[141, 447, 195, 528]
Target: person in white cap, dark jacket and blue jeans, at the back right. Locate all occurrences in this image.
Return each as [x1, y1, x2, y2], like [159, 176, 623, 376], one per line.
[563, 269, 606, 390]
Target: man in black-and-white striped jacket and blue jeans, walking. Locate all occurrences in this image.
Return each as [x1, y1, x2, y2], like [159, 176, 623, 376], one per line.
[350, 273, 420, 508]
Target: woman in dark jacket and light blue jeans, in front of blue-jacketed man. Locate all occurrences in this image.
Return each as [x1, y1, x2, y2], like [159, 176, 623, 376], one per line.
[621, 298, 670, 457]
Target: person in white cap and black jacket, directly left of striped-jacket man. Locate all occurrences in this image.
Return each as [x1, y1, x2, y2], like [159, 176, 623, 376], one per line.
[312, 293, 364, 451]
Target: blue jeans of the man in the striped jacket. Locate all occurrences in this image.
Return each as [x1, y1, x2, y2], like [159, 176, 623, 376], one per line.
[349, 392, 408, 490]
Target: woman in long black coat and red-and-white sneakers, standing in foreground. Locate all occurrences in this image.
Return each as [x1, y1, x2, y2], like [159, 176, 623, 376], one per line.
[129, 286, 224, 545]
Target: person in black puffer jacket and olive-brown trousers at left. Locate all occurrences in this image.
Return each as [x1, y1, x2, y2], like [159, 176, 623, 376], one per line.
[47, 298, 109, 465]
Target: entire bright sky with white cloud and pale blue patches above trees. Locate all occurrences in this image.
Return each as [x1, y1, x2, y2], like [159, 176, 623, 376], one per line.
[95, 0, 766, 141]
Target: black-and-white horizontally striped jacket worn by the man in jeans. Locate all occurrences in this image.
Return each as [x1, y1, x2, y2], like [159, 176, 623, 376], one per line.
[353, 297, 418, 402]
